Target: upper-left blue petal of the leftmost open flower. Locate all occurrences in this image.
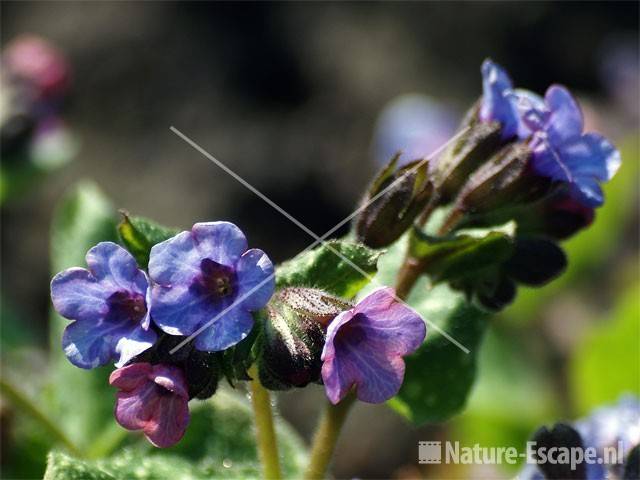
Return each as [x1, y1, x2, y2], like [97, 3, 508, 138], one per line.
[51, 268, 114, 322]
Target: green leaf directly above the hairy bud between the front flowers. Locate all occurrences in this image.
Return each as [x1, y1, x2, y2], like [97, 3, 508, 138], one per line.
[276, 240, 381, 299]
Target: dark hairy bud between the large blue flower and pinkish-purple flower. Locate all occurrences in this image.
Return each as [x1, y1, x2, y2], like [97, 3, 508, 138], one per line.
[258, 287, 351, 390]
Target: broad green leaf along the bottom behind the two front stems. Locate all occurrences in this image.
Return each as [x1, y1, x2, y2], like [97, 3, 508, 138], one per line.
[45, 391, 307, 480]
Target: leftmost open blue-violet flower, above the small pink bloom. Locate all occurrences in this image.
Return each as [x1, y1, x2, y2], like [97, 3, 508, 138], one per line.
[51, 242, 156, 368]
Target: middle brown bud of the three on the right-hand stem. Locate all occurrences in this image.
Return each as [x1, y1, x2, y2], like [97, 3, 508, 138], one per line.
[429, 102, 504, 204]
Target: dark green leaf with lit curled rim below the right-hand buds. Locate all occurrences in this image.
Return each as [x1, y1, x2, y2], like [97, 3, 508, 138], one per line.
[410, 222, 515, 283]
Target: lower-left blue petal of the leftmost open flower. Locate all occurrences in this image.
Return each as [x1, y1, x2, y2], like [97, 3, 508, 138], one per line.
[62, 320, 140, 368]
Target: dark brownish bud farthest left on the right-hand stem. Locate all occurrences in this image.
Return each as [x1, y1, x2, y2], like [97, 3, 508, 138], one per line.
[355, 154, 433, 248]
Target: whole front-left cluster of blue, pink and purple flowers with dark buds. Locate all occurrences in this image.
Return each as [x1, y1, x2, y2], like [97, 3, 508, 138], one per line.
[51, 222, 426, 447]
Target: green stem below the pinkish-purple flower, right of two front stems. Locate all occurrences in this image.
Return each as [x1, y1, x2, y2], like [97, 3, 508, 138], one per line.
[304, 394, 355, 480]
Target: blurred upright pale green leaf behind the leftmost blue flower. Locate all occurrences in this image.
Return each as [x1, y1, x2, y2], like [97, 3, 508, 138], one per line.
[44, 182, 116, 446]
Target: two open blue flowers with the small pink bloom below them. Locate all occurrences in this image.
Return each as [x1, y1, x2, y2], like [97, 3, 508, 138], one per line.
[51, 222, 275, 446]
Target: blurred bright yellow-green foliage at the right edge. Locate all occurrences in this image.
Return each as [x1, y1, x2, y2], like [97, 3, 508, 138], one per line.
[569, 282, 640, 414]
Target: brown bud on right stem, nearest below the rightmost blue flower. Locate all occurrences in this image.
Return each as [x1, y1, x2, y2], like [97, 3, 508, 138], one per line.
[455, 144, 551, 214]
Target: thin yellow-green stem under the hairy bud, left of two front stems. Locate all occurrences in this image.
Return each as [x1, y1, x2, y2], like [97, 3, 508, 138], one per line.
[249, 364, 282, 480]
